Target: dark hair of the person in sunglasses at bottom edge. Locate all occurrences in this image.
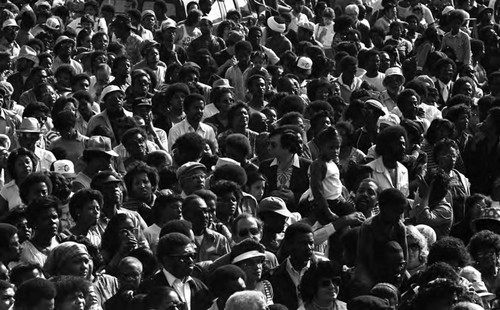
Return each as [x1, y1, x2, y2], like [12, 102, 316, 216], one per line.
[299, 261, 341, 303]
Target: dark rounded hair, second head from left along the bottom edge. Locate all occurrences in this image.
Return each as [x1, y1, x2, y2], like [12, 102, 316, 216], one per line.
[14, 278, 57, 309]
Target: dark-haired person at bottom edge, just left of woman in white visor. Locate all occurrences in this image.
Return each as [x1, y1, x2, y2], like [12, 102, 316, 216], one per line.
[209, 265, 246, 310]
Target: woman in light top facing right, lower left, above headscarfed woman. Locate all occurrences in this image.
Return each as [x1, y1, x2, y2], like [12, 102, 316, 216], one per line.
[20, 197, 59, 266]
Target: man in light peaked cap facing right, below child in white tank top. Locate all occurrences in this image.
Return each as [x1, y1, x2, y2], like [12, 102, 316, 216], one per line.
[259, 197, 293, 254]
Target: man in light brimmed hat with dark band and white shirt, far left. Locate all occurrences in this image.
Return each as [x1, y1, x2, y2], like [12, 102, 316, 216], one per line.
[17, 117, 56, 171]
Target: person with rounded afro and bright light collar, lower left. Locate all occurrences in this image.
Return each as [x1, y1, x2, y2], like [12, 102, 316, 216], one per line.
[64, 188, 104, 247]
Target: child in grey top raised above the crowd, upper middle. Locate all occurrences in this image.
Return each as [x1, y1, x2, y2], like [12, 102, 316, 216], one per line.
[225, 41, 252, 100]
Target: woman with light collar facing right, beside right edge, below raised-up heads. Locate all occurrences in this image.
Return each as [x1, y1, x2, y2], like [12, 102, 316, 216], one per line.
[432, 139, 470, 223]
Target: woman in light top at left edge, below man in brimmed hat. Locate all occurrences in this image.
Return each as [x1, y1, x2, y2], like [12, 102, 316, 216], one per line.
[0, 148, 38, 218]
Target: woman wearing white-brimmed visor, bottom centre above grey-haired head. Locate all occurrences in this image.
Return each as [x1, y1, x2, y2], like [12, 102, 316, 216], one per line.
[230, 239, 274, 305]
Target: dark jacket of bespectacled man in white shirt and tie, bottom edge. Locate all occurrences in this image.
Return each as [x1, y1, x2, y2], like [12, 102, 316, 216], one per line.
[139, 269, 213, 310]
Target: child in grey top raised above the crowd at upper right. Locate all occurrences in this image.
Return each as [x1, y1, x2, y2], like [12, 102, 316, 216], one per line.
[441, 10, 472, 71]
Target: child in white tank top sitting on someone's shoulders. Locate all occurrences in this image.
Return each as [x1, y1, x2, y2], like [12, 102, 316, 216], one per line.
[309, 127, 355, 225]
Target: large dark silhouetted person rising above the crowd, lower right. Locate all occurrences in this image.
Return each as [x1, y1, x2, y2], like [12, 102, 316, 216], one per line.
[355, 188, 408, 295]
